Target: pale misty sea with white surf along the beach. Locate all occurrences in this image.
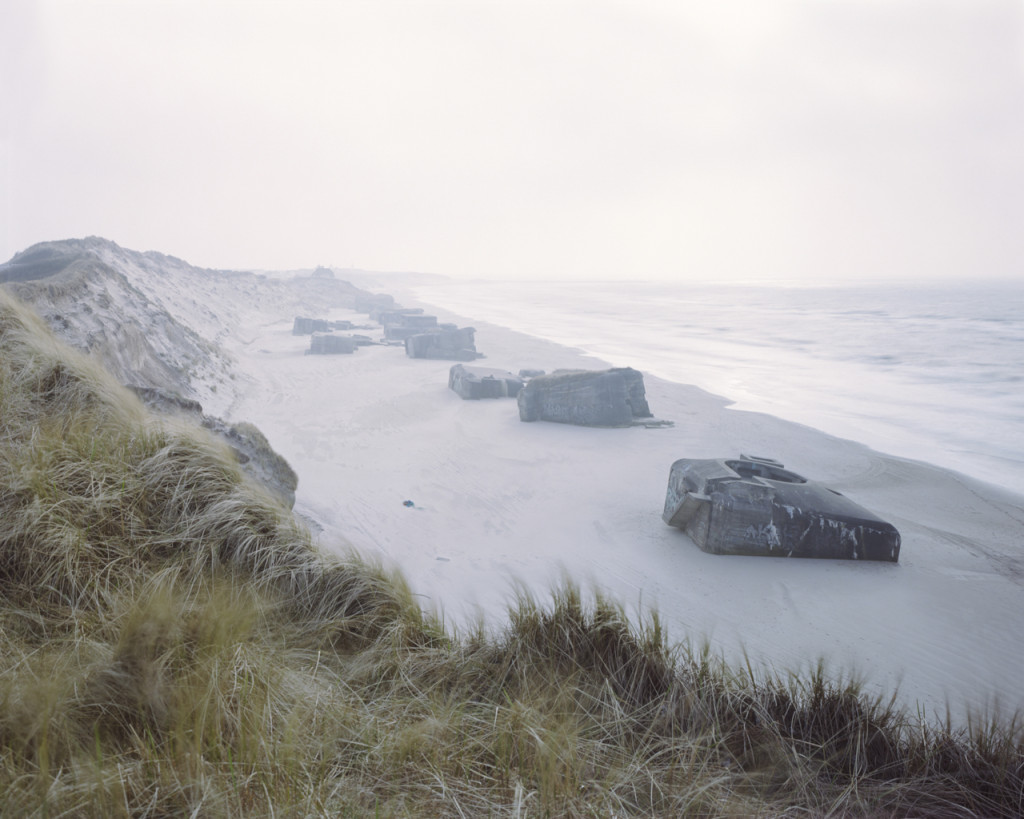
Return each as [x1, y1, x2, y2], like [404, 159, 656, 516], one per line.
[416, 281, 1024, 493]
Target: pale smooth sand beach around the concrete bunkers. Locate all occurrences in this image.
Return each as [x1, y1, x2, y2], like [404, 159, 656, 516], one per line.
[231, 294, 1024, 720]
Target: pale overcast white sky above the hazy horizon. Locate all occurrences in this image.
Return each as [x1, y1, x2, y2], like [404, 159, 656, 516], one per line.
[0, 0, 1024, 283]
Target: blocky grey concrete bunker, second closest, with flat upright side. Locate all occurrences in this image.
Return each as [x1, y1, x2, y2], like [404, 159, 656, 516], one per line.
[518, 367, 652, 427]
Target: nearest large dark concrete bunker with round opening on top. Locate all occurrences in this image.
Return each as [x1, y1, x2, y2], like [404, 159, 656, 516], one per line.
[662, 456, 900, 563]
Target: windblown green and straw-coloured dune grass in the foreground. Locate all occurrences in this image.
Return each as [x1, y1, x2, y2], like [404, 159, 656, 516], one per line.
[0, 293, 1024, 817]
